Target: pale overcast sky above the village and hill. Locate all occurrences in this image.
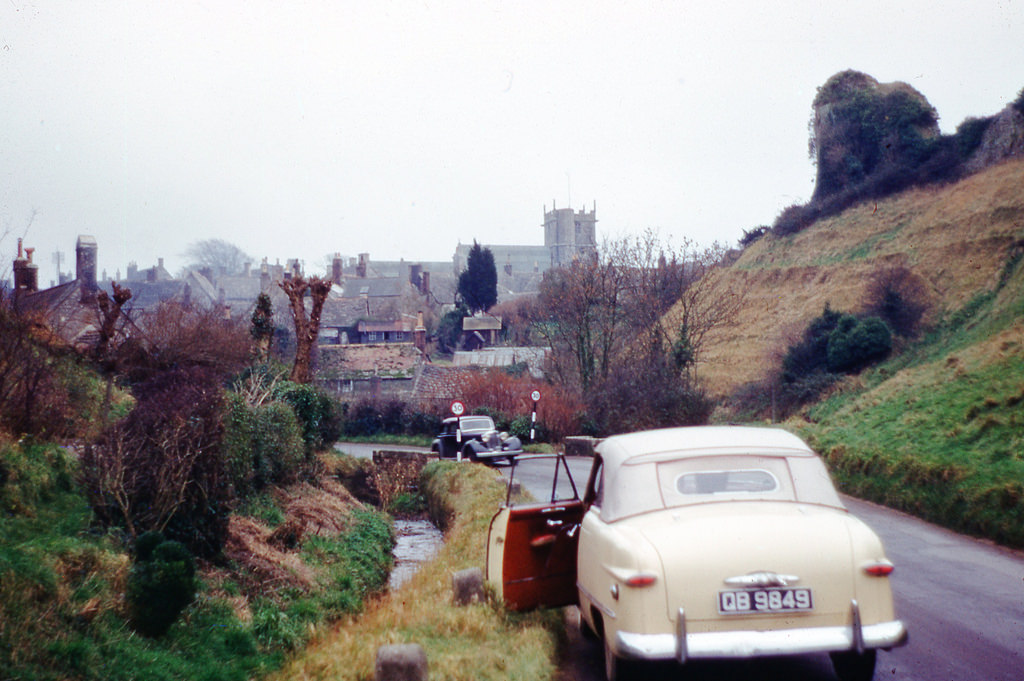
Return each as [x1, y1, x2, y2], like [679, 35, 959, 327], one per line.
[0, 0, 1024, 286]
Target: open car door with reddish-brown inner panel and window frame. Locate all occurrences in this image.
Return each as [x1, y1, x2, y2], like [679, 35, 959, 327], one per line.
[486, 455, 584, 611]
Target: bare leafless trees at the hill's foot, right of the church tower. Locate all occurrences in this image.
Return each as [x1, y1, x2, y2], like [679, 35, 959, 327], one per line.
[537, 231, 741, 431]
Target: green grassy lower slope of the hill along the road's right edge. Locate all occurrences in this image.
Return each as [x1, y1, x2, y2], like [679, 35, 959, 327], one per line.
[795, 258, 1024, 547]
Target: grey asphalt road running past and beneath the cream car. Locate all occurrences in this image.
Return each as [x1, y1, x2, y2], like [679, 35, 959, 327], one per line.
[339, 445, 1024, 681]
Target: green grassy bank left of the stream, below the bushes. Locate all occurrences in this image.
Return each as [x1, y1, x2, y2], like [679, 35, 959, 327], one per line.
[0, 442, 393, 681]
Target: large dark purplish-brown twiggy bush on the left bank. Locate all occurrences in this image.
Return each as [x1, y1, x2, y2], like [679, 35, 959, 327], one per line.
[82, 367, 231, 556]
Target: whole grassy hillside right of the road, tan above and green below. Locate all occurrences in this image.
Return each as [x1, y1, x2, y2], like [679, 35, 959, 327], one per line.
[699, 156, 1024, 547]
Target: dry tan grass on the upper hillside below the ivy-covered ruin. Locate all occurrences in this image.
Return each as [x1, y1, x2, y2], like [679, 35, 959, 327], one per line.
[697, 160, 1024, 396]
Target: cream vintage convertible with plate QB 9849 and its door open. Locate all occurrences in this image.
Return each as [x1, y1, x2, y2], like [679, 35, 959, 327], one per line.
[487, 426, 907, 681]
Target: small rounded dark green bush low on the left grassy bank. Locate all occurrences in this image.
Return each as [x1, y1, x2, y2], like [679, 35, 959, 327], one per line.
[128, 531, 199, 637]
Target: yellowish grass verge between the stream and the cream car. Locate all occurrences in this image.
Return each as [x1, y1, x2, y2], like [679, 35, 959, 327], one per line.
[272, 461, 564, 681]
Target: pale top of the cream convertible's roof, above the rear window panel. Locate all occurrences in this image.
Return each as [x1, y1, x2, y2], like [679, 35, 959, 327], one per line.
[597, 426, 816, 469]
